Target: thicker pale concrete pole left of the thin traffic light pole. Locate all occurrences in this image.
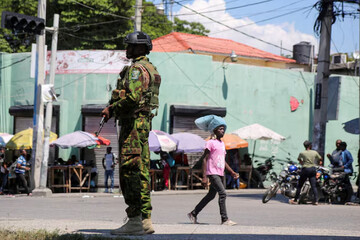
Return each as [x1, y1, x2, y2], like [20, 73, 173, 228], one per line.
[30, 0, 46, 194]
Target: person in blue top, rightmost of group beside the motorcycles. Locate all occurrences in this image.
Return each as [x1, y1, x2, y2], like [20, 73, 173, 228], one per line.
[340, 142, 354, 203]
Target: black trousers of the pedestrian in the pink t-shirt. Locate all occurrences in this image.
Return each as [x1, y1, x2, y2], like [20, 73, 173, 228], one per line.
[191, 175, 228, 223]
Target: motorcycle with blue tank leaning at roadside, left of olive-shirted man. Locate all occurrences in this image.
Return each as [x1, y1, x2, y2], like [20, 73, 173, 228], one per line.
[262, 162, 300, 203]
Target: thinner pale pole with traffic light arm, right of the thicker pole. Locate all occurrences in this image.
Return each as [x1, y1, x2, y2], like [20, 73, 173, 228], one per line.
[40, 14, 59, 196]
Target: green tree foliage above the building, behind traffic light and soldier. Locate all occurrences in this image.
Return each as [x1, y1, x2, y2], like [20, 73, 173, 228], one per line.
[0, 0, 209, 52]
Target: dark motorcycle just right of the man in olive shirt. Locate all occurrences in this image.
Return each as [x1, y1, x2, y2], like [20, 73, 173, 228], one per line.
[299, 166, 348, 204]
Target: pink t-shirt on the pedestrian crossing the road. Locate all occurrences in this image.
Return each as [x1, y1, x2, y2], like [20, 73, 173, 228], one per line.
[205, 139, 226, 176]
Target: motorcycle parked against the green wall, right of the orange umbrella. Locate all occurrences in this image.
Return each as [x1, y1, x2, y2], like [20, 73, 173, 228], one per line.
[251, 156, 277, 188]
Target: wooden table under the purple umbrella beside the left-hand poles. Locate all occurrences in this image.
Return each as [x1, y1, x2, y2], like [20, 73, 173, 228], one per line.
[49, 165, 91, 193]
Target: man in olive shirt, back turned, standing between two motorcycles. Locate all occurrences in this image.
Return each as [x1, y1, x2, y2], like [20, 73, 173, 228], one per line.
[289, 140, 322, 205]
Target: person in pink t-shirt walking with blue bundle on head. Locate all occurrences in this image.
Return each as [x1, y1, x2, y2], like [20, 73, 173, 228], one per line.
[187, 115, 239, 226]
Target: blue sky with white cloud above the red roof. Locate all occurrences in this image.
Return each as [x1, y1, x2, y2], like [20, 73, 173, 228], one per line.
[152, 0, 360, 55]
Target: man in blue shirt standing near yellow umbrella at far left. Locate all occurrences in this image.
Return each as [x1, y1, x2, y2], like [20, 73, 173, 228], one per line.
[14, 149, 32, 196]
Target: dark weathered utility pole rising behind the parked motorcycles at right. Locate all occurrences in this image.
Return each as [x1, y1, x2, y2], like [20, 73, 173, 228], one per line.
[313, 0, 333, 159]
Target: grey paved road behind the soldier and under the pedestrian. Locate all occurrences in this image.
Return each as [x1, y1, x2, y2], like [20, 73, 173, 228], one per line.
[0, 189, 360, 240]
